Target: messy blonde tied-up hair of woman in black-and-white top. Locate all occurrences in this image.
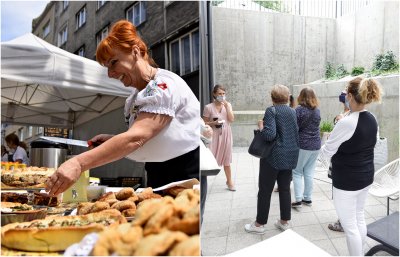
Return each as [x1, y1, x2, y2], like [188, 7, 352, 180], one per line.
[347, 77, 383, 104]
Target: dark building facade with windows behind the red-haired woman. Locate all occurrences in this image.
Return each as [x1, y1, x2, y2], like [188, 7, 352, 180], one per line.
[32, 1, 200, 98]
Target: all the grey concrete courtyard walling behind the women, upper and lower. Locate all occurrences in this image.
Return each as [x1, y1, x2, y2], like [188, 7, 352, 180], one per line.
[212, 1, 399, 159]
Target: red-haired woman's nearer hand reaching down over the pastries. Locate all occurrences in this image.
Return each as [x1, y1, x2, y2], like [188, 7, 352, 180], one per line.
[46, 157, 82, 196]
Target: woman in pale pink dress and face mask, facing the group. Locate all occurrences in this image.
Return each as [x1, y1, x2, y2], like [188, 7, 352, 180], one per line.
[203, 85, 236, 191]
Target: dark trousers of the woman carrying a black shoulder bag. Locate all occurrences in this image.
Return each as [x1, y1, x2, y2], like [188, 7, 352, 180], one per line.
[256, 158, 292, 225]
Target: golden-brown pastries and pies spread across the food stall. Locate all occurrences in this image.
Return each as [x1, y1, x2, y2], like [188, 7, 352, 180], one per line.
[1, 167, 200, 256]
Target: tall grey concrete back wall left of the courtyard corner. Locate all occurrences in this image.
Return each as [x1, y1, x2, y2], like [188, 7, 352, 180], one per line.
[212, 7, 335, 110]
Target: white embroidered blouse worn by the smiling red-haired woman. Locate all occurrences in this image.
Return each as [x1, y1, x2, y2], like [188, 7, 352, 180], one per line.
[124, 69, 200, 162]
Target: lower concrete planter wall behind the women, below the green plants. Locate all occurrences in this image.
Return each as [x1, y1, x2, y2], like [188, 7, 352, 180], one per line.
[232, 75, 399, 160]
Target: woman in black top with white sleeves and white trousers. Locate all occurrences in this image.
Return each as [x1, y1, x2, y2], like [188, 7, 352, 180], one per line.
[321, 77, 381, 256]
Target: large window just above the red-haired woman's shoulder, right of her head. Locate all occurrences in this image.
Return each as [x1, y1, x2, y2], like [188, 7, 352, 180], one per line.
[170, 30, 200, 75]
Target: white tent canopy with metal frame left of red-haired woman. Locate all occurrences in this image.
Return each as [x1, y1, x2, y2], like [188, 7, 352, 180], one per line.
[1, 33, 131, 128]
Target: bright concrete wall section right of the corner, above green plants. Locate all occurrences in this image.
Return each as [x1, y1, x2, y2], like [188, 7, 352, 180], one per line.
[336, 1, 399, 72]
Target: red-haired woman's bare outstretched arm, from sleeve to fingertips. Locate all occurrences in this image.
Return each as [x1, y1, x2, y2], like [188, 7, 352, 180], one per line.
[46, 112, 172, 195]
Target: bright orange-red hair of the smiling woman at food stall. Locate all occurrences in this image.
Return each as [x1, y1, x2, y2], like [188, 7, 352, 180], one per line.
[96, 20, 158, 67]
